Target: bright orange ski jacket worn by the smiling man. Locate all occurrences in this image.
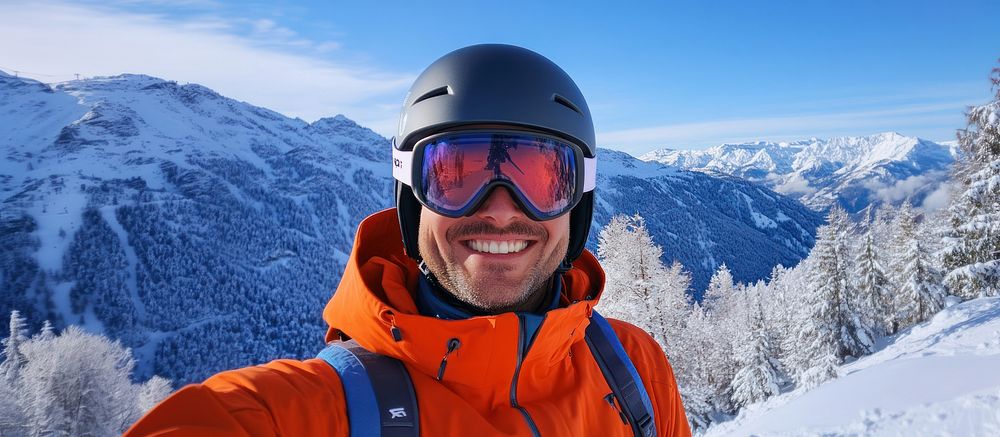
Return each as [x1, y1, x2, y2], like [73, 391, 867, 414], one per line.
[126, 209, 691, 437]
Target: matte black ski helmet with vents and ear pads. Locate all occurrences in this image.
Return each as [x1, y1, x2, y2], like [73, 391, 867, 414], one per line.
[392, 44, 597, 262]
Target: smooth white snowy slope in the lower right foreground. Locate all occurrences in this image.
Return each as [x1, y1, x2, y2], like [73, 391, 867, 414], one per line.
[706, 297, 1000, 436]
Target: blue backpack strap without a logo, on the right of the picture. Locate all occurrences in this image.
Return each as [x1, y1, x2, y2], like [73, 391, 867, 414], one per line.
[585, 311, 656, 437]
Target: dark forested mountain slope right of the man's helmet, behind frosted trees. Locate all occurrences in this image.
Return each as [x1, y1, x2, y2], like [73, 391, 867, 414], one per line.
[590, 149, 822, 297]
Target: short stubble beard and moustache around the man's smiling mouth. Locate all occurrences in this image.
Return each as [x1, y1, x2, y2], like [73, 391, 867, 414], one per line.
[418, 223, 569, 314]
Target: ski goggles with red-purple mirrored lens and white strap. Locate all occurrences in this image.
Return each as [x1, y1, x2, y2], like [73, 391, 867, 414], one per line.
[392, 130, 597, 221]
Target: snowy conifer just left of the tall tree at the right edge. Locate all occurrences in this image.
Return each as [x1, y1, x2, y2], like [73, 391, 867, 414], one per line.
[896, 237, 946, 327]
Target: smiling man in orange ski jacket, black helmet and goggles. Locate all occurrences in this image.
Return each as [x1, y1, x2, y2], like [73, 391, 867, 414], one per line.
[129, 44, 690, 436]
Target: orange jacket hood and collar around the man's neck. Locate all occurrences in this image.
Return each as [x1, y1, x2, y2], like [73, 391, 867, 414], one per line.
[323, 209, 604, 386]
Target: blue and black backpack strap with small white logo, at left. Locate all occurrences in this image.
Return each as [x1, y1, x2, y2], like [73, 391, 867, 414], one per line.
[317, 340, 420, 437]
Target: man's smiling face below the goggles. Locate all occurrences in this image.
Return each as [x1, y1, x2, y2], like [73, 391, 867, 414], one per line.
[418, 187, 570, 314]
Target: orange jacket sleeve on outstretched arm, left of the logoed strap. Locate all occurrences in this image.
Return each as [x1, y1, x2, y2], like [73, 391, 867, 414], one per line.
[125, 359, 348, 437]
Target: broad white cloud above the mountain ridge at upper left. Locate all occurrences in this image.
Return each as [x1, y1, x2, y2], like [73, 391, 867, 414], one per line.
[0, 2, 414, 136]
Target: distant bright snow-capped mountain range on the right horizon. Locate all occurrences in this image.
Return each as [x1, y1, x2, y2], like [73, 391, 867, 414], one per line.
[640, 132, 957, 212]
